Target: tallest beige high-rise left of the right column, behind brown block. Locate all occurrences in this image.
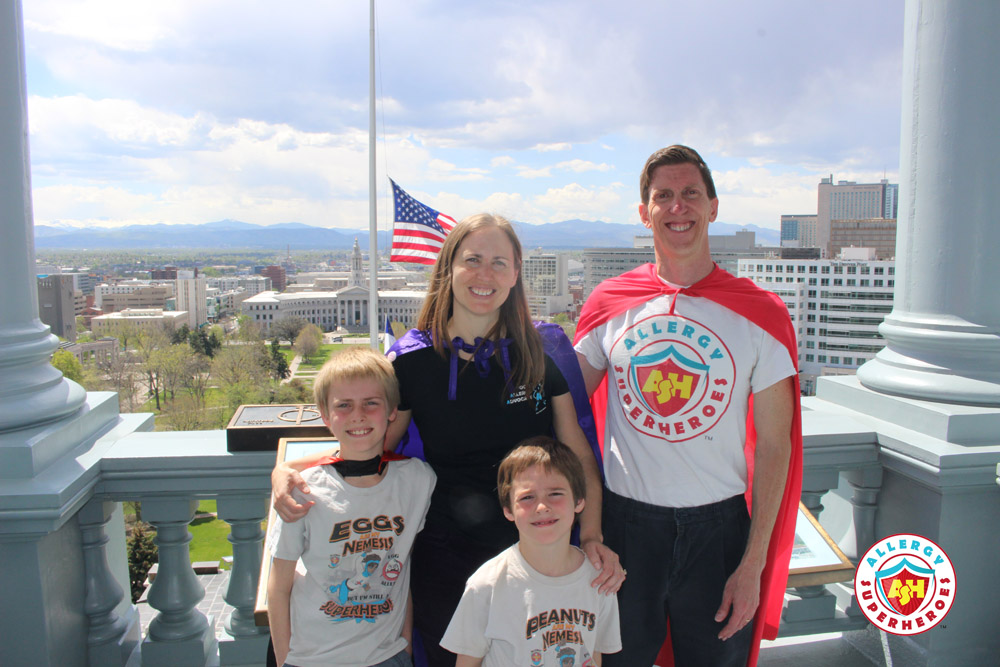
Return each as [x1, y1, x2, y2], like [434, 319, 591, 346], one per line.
[816, 174, 899, 257]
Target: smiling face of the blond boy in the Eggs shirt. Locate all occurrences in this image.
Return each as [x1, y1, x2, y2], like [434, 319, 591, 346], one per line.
[323, 378, 396, 461]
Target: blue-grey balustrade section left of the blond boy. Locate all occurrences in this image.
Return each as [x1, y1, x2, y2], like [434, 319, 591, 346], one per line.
[84, 431, 274, 665]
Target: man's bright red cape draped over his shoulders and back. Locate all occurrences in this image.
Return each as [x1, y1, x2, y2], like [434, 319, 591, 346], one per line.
[574, 264, 802, 667]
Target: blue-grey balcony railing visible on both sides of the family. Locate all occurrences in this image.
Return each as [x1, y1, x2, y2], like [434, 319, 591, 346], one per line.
[58, 410, 881, 666]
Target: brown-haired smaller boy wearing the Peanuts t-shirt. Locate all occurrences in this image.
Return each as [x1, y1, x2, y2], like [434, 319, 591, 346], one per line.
[441, 436, 621, 667]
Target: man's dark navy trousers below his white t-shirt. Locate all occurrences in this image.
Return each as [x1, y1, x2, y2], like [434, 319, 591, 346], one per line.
[602, 489, 753, 667]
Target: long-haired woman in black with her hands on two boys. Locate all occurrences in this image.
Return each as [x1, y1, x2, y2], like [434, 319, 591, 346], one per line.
[272, 214, 624, 667]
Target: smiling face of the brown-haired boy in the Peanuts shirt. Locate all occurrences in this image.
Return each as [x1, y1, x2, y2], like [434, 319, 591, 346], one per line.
[503, 465, 584, 544]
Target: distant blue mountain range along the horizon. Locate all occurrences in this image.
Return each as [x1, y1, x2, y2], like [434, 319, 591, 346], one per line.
[35, 220, 780, 251]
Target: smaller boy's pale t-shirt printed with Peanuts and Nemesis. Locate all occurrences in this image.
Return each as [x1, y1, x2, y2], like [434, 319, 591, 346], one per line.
[441, 544, 622, 667]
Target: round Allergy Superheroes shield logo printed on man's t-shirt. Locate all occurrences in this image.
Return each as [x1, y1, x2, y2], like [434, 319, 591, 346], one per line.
[611, 315, 736, 442]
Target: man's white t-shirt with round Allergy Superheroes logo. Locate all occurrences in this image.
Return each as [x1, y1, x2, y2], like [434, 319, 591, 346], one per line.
[575, 294, 795, 507]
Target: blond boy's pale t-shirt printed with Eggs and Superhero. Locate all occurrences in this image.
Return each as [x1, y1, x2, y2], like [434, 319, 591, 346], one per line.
[271, 459, 435, 667]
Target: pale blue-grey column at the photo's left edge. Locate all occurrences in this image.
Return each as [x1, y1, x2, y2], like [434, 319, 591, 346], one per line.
[0, 0, 85, 434]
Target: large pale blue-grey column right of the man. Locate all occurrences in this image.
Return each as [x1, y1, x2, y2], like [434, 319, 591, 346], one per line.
[858, 0, 1000, 406]
